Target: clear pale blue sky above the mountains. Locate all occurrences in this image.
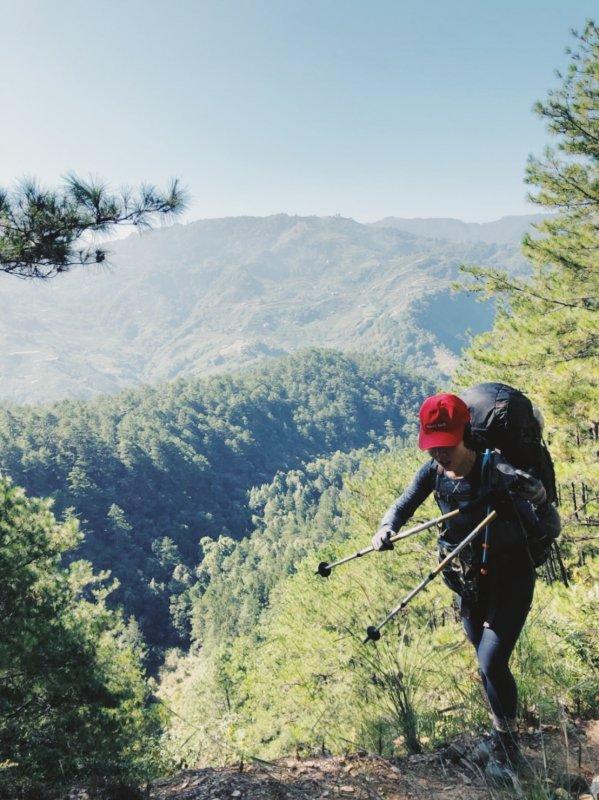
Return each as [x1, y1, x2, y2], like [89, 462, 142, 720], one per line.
[0, 0, 597, 221]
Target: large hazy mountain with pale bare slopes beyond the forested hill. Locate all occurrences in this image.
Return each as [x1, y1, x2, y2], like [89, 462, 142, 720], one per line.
[0, 214, 529, 402]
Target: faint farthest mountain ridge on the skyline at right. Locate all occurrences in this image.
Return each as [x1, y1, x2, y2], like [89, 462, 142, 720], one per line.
[372, 214, 546, 244]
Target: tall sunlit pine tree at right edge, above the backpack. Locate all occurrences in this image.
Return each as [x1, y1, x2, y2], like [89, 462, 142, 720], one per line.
[458, 21, 599, 453]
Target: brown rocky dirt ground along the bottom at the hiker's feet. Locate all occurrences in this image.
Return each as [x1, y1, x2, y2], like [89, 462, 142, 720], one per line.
[150, 721, 599, 800]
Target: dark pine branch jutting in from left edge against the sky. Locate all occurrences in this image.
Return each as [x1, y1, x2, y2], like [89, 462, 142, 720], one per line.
[0, 175, 186, 279]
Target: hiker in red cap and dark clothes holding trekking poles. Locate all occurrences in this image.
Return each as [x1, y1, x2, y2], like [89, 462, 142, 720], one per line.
[372, 393, 559, 770]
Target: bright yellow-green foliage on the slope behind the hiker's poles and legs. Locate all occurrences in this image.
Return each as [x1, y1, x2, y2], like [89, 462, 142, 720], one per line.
[160, 448, 599, 765]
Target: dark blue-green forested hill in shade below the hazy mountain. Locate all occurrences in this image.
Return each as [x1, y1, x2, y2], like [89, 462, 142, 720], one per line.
[0, 351, 432, 647]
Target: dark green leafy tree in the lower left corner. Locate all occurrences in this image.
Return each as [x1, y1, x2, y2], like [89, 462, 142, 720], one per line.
[0, 480, 166, 798]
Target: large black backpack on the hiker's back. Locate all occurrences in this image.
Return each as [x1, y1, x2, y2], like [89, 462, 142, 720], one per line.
[460, 383, 557, 503]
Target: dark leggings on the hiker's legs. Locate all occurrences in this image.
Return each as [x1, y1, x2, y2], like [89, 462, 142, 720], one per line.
[462, 572, 535, 726]
